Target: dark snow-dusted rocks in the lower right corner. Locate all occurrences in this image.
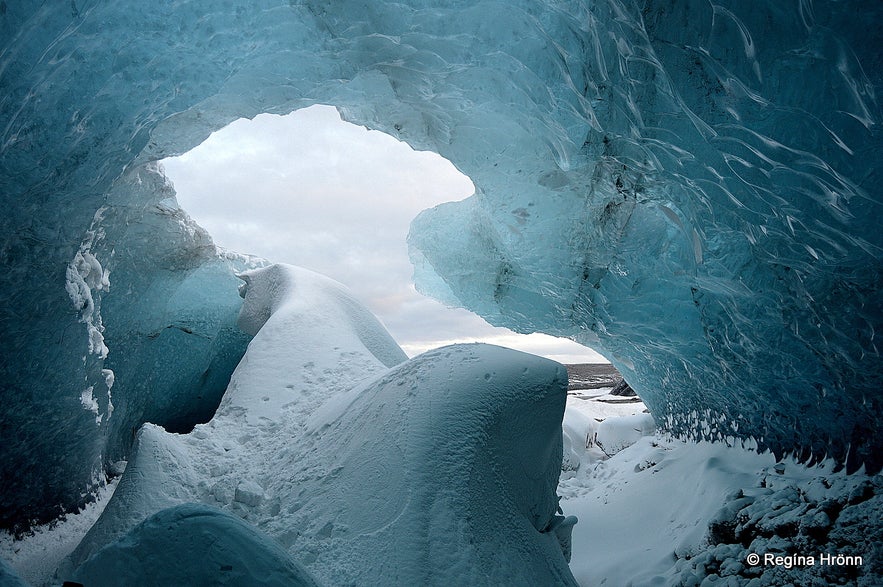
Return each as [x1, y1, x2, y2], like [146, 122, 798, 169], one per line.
[674, 475, 883, 587]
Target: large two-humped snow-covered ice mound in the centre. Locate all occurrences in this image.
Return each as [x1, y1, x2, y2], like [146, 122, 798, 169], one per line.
[59, 265, 575, 585]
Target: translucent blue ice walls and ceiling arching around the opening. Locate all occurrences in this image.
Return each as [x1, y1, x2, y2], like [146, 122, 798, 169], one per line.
[0, 0, 883, 527]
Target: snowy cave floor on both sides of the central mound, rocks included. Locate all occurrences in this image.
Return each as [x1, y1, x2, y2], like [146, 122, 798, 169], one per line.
[0, 389, 883, 587]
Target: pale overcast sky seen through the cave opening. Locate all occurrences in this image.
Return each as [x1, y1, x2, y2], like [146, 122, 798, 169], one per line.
[163, 106, 606, 363]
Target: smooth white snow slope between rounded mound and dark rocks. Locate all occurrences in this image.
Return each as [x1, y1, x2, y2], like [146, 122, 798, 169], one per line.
[559, 436, 775, 586]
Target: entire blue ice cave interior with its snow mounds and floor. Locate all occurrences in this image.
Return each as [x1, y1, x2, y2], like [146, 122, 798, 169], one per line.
[0, 0, 883, 586]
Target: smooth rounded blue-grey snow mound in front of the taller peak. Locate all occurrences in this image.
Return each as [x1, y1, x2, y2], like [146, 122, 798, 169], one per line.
[280, 345, 575, 585]
